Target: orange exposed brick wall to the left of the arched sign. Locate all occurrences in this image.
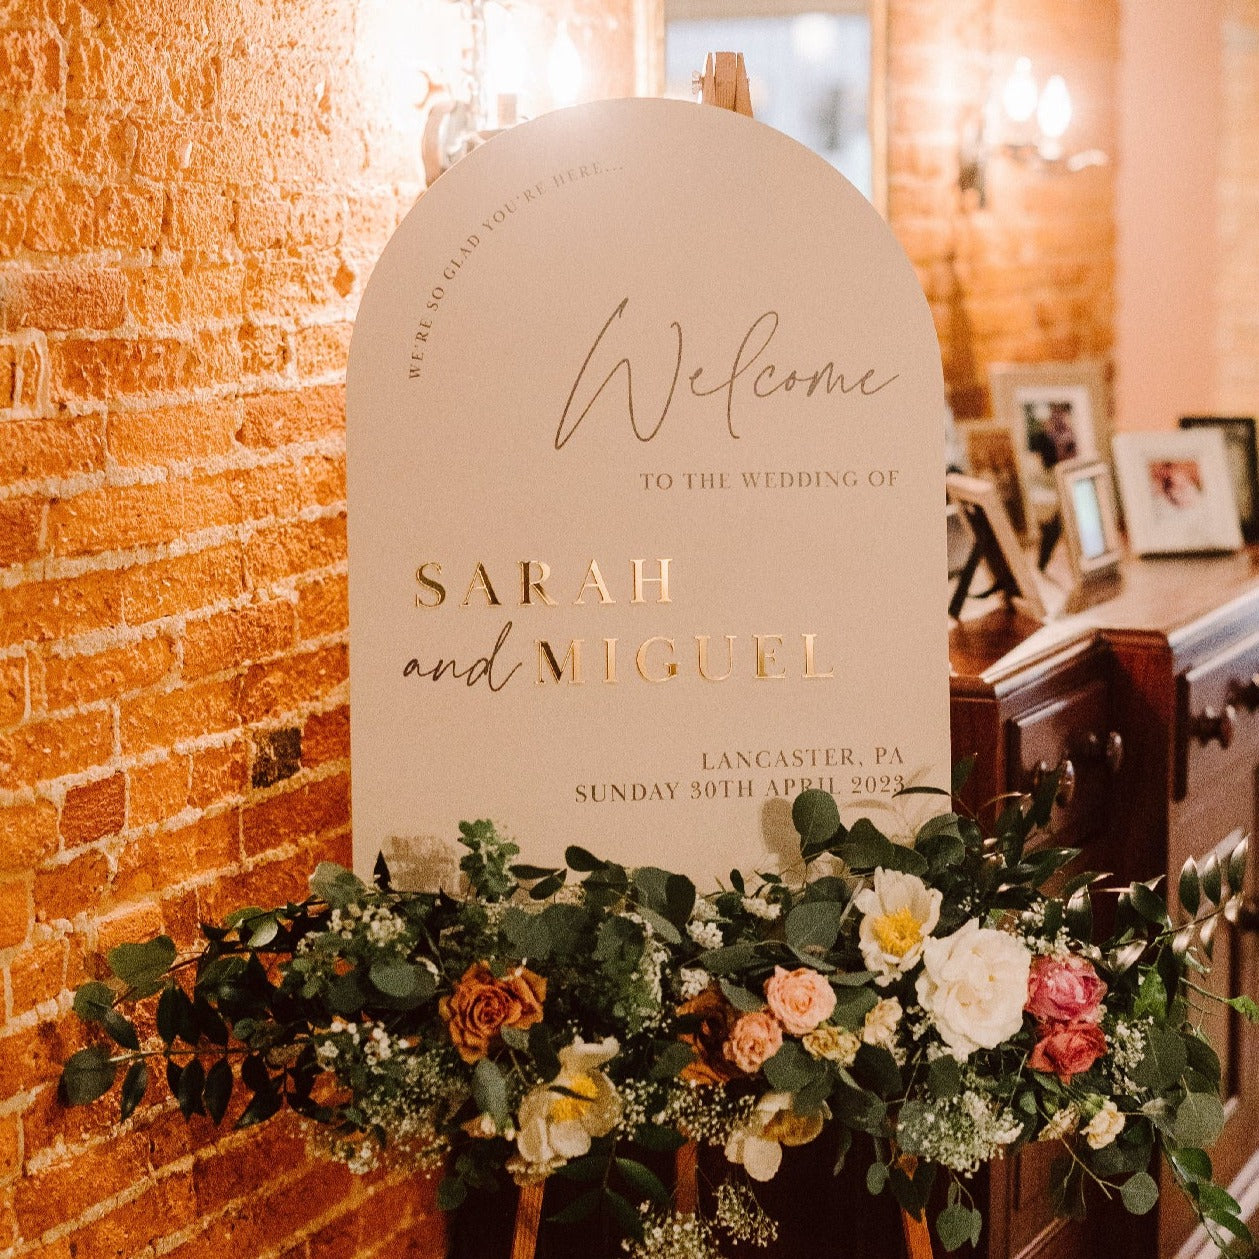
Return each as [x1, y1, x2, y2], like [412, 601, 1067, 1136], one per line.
[0, 0, 633, 1259]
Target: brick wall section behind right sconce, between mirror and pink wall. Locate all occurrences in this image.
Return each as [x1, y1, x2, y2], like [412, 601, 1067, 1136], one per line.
[888, 0, 1119, 417]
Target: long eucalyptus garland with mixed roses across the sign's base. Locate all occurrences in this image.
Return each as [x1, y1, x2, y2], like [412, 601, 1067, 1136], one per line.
[62, 767, 1259, 1259]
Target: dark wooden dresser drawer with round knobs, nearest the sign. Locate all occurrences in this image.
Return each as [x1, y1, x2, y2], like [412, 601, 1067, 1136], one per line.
[1007, 677, 1123, 846]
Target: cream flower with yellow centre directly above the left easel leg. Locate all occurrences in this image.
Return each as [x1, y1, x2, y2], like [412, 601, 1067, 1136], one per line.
[516, 1036, 621, 1168]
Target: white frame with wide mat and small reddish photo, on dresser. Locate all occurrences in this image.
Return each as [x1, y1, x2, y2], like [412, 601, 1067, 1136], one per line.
[1114, 427, 1241, 555]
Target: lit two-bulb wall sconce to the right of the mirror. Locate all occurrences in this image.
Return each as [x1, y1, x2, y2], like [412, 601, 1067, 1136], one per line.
[958, 57, 1108, 208]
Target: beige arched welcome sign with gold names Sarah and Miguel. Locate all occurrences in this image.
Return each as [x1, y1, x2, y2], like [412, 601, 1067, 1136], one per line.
[347, 101, 949, 883]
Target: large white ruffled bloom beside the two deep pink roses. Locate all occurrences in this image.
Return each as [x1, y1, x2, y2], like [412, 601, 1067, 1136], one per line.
[918, 918, 1031, 1061]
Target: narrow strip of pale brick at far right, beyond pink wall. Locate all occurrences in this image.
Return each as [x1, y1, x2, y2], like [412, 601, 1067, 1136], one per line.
[1216, 0, 1259, 415]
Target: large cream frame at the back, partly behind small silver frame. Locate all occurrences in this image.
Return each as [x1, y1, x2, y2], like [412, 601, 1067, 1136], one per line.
[988, 359, 1110, 541]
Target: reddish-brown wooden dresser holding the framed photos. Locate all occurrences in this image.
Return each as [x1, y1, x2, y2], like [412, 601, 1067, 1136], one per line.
[951, 548, 1259, 1259]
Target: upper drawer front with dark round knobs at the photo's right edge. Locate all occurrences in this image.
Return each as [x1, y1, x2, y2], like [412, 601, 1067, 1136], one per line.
[1175, 633, 1259, 799]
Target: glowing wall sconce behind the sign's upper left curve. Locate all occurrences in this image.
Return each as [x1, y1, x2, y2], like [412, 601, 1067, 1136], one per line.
[421, 0, 585, 186]
